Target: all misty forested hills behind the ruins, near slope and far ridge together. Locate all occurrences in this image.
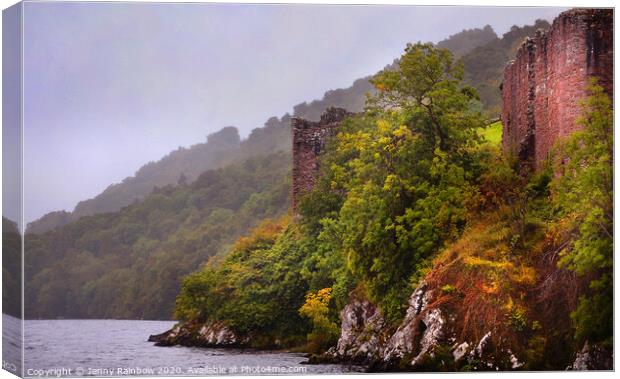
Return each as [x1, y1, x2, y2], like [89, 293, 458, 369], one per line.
[26, 20, 552, 319]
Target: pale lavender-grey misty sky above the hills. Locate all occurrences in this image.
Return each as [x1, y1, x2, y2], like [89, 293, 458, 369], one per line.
[17, 2, 561, 222]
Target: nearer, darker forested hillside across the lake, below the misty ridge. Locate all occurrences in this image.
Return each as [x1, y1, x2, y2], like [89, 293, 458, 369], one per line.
[25, 152, 290, 319]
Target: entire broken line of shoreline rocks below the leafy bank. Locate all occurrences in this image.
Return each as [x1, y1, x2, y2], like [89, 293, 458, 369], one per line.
[148, 282, 613, 372]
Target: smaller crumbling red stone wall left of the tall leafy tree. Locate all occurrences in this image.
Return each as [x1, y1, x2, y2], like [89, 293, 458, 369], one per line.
[291, 108, 351, 209]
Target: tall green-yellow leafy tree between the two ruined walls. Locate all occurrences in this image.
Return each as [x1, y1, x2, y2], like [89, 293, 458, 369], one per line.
[301, 43, 483, 321]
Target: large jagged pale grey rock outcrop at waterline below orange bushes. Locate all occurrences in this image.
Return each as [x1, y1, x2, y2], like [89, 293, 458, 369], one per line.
[324, 282, 524, 371]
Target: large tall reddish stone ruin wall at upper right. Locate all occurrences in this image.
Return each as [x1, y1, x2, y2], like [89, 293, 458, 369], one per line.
[502, 9, 613, 169]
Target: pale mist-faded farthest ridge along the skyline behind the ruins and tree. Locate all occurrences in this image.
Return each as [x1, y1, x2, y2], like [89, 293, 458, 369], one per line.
[28, 24, 520, 233]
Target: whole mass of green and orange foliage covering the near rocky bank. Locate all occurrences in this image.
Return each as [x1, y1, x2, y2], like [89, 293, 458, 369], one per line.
[176, 44, 613, 369]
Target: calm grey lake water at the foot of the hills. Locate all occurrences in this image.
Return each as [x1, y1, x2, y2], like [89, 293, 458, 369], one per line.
[12, 320, 360, 377]
